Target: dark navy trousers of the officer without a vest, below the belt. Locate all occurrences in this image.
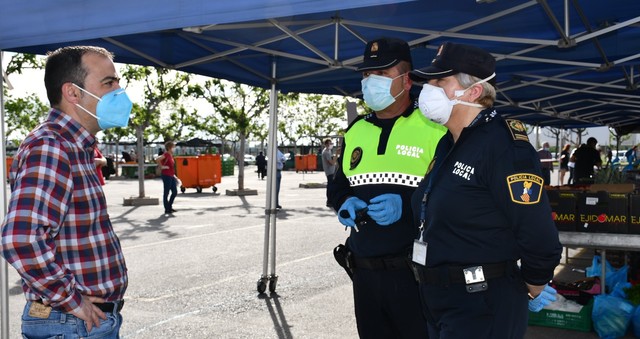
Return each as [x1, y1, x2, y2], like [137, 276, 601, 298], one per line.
[420, 272, 528, 339]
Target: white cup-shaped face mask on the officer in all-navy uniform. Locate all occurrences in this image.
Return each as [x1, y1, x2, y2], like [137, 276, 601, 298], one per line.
[418, 73, 496, 125]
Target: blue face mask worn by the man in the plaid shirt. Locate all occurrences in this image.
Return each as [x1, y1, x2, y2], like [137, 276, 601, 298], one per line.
[73, 84, 133, 130]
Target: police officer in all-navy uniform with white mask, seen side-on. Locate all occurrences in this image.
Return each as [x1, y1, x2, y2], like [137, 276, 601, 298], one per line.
[411, 43, 562, 339]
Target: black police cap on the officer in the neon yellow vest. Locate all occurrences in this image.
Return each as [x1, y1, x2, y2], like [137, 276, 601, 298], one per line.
[356, 38, 412, 72]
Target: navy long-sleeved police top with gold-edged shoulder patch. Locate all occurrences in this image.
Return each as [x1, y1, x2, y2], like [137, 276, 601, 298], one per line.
[412, 109, 562, 285]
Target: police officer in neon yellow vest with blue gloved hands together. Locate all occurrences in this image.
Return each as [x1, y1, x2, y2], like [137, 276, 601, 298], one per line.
[328, 38, 446, 338]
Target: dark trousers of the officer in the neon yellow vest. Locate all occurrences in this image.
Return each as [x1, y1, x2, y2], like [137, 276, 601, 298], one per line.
[353, 265, 428, 339]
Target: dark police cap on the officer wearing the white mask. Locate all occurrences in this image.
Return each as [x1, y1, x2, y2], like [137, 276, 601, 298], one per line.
[409, 42, 496, 86]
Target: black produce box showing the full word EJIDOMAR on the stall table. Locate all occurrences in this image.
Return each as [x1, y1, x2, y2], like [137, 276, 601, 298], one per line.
[576, 191, 629, 234]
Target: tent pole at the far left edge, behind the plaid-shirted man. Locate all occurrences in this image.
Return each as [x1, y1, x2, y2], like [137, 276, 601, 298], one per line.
[0, 50, 9, 339]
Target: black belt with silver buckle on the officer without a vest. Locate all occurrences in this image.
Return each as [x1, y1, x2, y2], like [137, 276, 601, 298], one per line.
[411, 261, 516, 293]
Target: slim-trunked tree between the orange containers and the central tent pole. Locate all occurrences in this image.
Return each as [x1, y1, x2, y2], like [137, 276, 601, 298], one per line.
[189, 79, 269, 191]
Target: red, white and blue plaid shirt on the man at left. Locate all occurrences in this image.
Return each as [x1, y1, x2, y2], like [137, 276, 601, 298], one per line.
[0, 109, 127, 312]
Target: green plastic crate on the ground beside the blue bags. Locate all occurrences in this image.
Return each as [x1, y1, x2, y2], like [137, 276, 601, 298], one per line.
[529, 299, 593, 332]
